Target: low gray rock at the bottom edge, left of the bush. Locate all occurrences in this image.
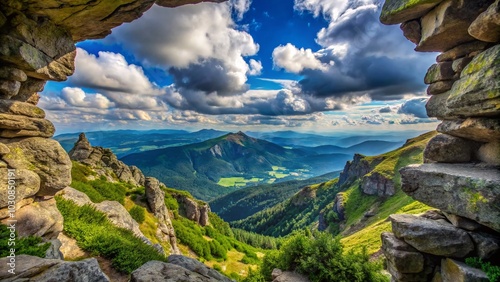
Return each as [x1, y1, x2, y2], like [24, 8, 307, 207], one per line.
[130, 255, 232, 282]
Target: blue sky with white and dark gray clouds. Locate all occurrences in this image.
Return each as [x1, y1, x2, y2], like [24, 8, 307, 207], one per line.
[40, 0, 436, 133]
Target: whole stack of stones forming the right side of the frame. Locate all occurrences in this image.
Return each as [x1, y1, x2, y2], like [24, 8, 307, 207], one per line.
[380, 0, 500, 281]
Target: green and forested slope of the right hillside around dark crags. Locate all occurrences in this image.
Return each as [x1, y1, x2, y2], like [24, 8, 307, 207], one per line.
[233, 132, 435, 253]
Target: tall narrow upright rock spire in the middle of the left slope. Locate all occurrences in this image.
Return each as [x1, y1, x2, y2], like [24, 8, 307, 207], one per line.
[145, 177, 180, 254]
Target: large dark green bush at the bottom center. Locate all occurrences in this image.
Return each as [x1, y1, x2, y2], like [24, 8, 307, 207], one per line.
[245, 232, 389, 282]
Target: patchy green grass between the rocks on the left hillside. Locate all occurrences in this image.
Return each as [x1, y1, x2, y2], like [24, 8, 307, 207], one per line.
[64, 162, 263, 279]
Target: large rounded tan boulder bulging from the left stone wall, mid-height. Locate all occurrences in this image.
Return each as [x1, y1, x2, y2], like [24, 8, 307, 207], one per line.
[0, 137, 71, 196]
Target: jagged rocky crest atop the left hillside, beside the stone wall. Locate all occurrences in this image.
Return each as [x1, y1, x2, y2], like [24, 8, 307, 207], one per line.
[69, 133, 144, 186]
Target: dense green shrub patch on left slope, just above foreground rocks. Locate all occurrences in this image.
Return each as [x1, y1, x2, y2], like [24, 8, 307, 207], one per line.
[56, 197, 166, 273]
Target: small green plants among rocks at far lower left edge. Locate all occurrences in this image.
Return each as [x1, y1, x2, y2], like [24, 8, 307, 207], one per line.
[0, 224, 50, 258]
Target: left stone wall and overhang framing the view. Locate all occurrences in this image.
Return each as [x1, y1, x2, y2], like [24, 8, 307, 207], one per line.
[0, 0, 224, 240]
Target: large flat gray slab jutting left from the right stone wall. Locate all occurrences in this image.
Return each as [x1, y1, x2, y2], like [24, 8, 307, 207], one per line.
[400, 163, 500, 232]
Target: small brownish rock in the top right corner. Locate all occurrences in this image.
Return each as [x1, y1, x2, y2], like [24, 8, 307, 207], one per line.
[469, 0, 500, 42]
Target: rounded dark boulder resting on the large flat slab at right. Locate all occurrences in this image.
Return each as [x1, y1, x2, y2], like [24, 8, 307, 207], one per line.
[424, 134, 477, 163]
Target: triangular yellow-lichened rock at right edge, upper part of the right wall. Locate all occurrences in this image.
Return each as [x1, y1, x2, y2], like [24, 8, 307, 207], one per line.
[446, 45, 500, 117]
